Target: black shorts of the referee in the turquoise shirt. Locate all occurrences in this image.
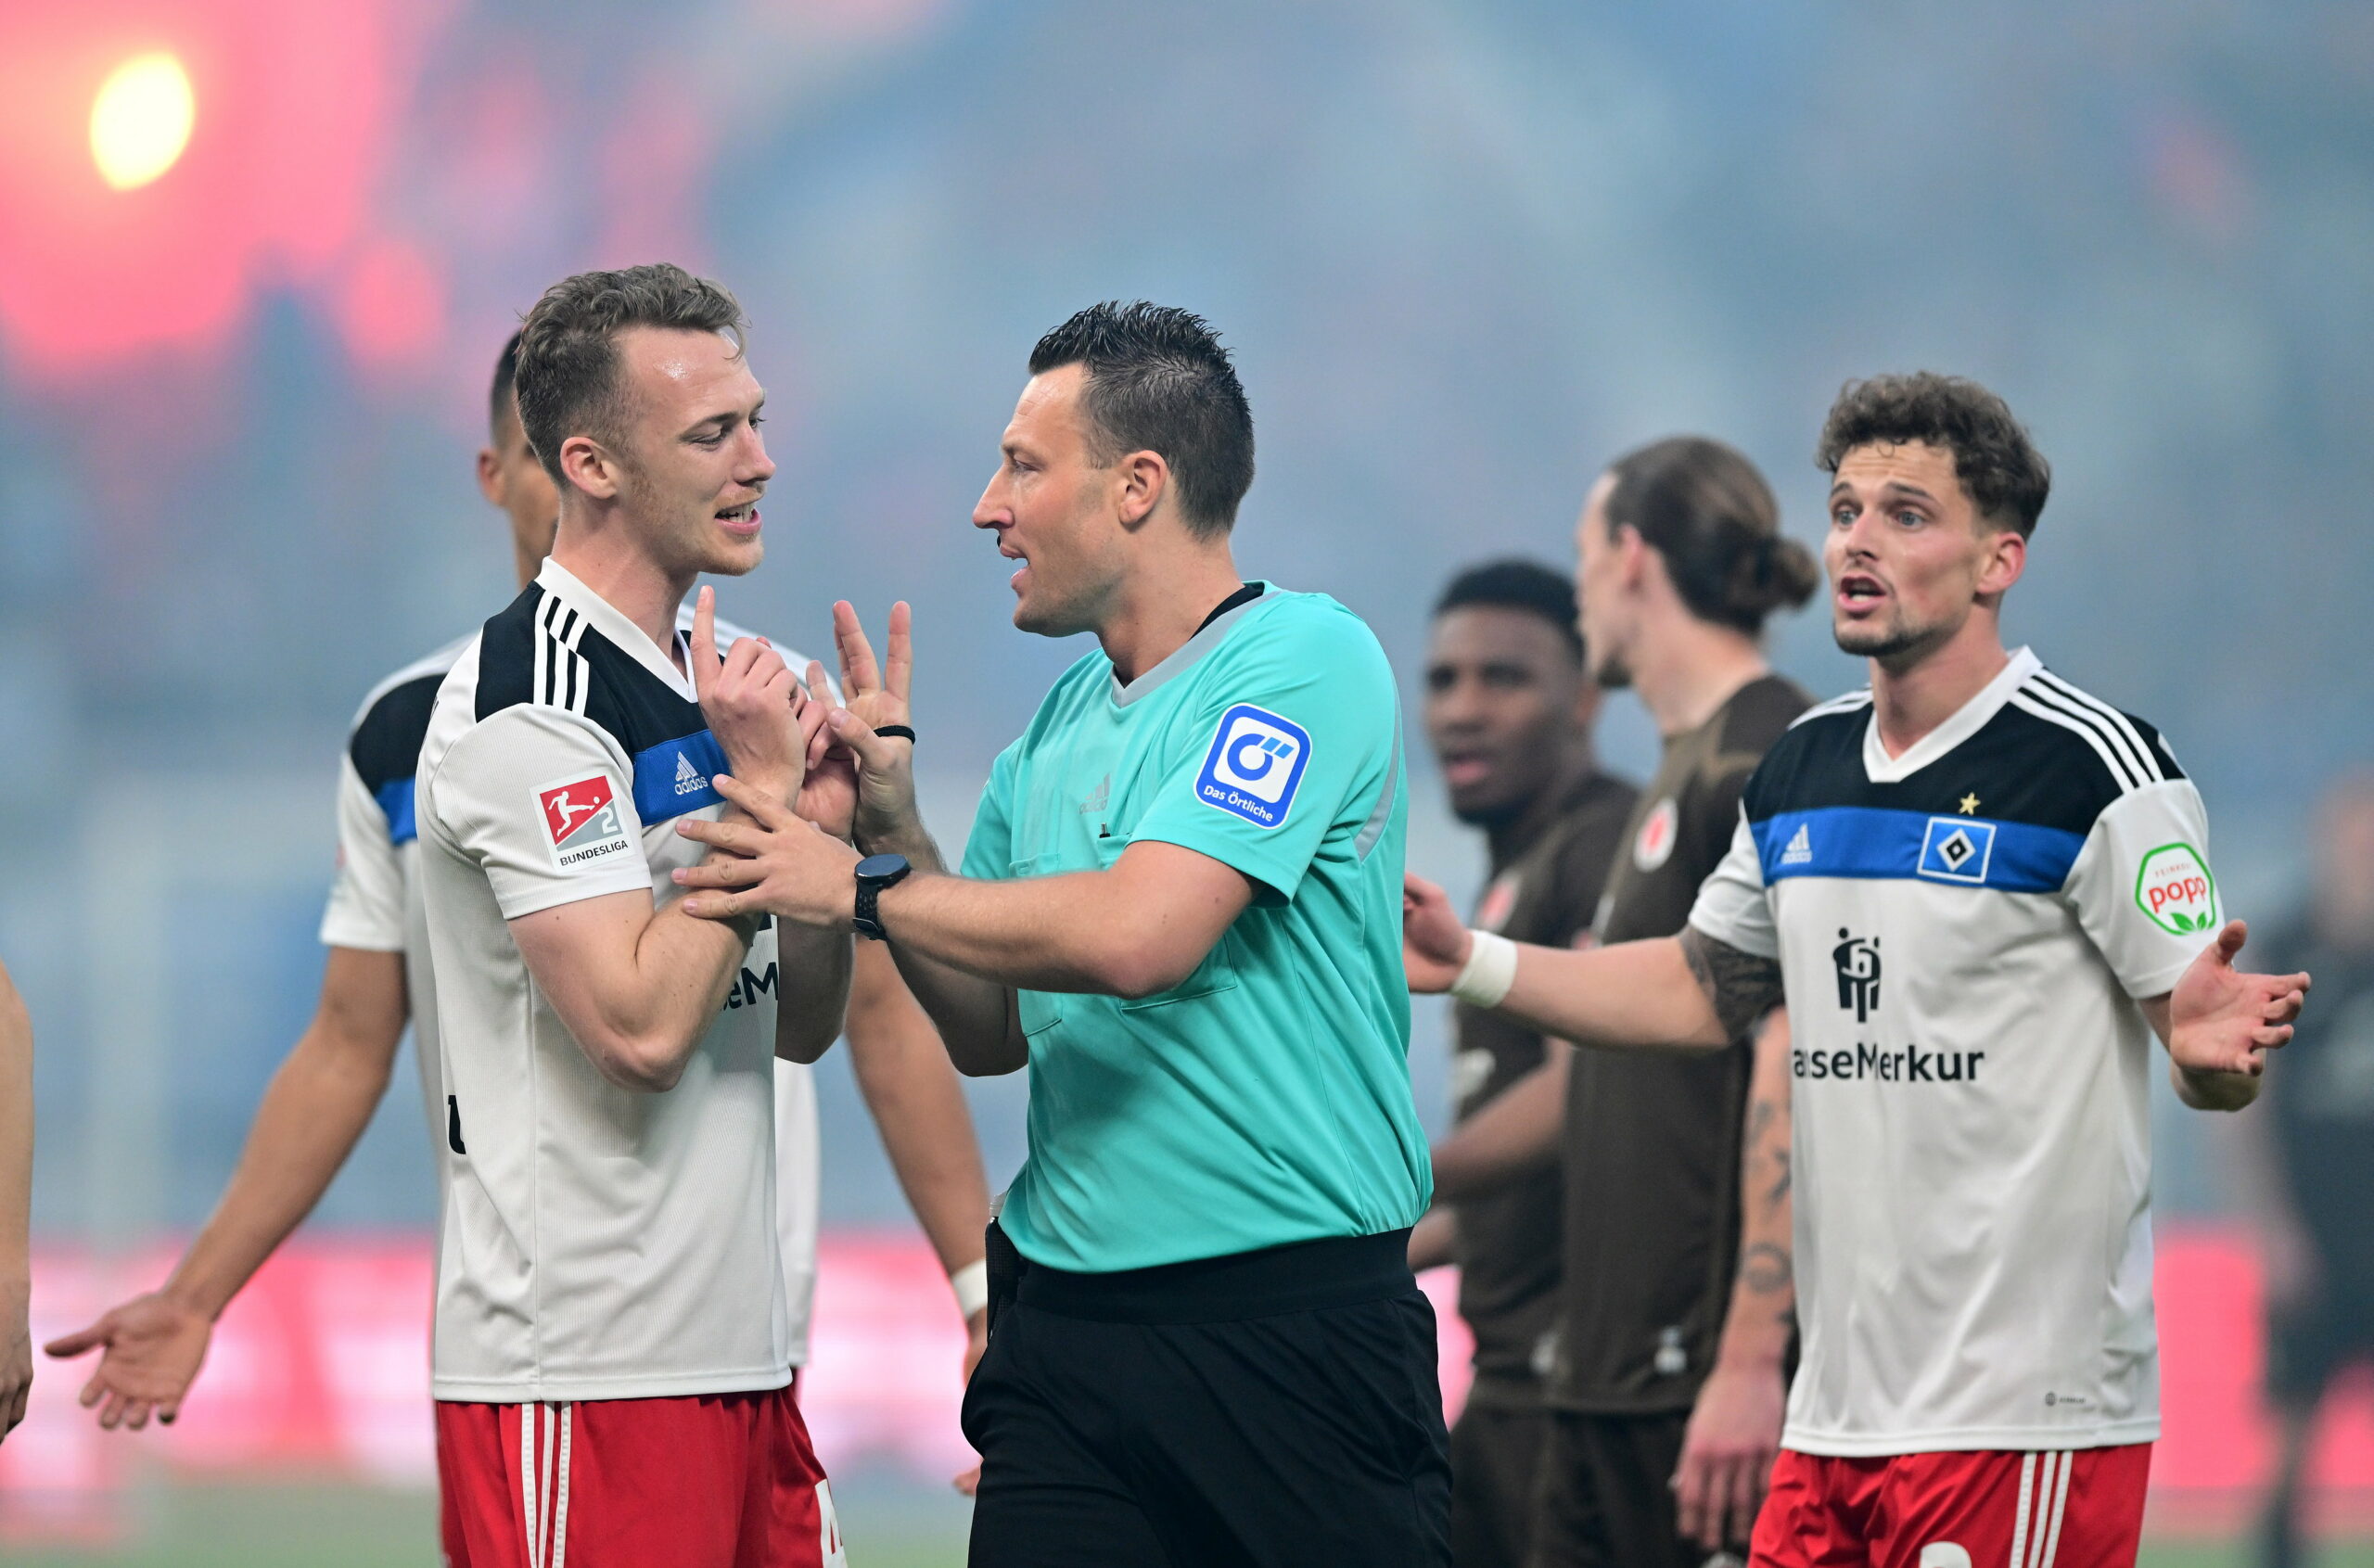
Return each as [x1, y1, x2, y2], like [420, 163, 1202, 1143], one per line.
[964, 1231, 1450, 1568]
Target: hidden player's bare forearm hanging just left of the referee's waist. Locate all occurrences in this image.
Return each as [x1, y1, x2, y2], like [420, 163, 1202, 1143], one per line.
[849, 944, 990, 1274]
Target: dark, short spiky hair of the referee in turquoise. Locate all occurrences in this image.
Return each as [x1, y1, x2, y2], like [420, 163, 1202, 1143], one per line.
[1030, 299, 1254, 536]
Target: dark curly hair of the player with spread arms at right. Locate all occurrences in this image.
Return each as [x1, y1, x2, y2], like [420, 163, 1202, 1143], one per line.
[1814, 370, 2053, 539]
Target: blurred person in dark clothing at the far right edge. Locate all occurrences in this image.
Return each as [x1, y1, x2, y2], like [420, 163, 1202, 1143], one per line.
[2234, 771, 2374, 1568]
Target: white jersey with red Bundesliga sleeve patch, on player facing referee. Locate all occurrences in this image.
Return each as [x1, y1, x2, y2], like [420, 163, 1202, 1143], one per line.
[415, 560, 814, 1402]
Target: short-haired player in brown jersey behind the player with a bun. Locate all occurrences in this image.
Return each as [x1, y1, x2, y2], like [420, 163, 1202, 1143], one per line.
[1410, 560, 1638, 1568]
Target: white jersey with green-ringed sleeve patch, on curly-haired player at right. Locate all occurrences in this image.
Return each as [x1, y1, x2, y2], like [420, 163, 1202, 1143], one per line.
[1691, 647, 2220, 1457]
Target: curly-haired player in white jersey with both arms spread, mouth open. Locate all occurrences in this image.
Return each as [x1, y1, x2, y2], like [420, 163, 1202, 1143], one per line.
[1408, 375, 2307, 1568]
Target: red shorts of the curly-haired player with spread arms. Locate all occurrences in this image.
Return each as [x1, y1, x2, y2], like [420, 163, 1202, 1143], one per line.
[1752, 1442, 2151, 1568]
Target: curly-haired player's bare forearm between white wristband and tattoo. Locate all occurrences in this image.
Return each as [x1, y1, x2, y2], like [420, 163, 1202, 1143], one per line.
[1493, 937, 1735, 1051]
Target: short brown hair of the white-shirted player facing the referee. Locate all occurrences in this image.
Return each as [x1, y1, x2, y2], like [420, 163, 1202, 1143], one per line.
[516, 261, 746, 481]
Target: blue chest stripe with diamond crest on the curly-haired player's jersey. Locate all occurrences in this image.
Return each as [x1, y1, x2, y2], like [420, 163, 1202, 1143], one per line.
[1750, 807, 2085, 892]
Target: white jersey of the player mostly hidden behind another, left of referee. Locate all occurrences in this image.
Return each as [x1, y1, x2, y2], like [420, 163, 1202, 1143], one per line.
[321, 603, 823, 1367]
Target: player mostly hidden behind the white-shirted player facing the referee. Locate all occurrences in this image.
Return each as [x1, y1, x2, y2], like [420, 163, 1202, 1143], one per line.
[47, 332, 988, 1431]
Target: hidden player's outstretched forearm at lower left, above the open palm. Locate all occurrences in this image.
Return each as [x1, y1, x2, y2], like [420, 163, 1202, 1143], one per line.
[164, 987, 403, 1319]
